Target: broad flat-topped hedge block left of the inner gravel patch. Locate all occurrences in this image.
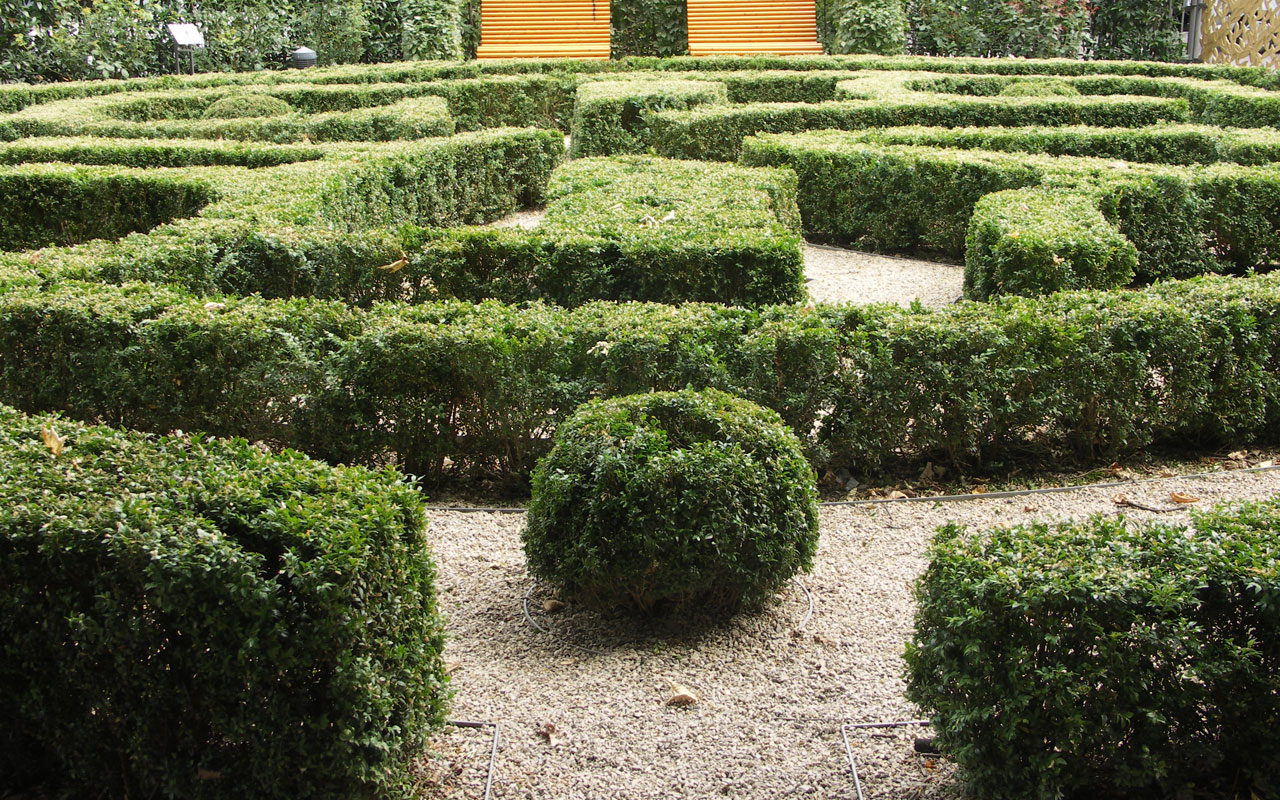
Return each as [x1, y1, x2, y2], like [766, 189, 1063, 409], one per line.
[538, 156, 805, 306]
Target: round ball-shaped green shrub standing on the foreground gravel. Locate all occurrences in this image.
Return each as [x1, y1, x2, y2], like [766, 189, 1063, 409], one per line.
[521, 390, 818, 614]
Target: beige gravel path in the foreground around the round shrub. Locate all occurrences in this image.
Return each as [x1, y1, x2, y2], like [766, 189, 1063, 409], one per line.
[426, 471, 1280, 800]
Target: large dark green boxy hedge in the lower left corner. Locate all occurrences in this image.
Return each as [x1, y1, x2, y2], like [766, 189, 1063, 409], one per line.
[0, 407, 448, 797]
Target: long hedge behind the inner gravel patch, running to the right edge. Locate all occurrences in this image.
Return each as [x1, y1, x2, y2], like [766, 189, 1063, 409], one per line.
[742, 131, 1280, 298]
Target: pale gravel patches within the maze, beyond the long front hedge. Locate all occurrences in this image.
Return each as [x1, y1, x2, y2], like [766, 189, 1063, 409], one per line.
[490, 209, 964, 308]
